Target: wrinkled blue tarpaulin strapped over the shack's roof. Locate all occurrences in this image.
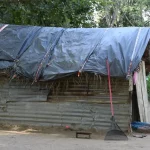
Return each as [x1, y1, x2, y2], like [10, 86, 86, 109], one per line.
[0, 24, 150, 80]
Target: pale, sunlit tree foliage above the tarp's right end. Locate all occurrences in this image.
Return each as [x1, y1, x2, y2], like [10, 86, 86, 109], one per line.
[99, 0, 150, 27]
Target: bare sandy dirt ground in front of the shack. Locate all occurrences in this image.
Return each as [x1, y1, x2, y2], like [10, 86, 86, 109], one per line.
[0, 126, 150, 150]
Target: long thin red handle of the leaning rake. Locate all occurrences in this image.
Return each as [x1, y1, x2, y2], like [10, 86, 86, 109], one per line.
[106, 59, 114, 116]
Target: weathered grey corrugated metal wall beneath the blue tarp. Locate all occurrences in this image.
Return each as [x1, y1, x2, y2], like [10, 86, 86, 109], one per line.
[0, 74, 130, 130]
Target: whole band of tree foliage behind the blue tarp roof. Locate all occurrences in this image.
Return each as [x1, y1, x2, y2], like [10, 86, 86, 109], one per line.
[0, 0, 150, 27]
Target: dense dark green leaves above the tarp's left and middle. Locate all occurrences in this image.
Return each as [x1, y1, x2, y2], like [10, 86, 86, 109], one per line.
[0, 0, 96, 27]
